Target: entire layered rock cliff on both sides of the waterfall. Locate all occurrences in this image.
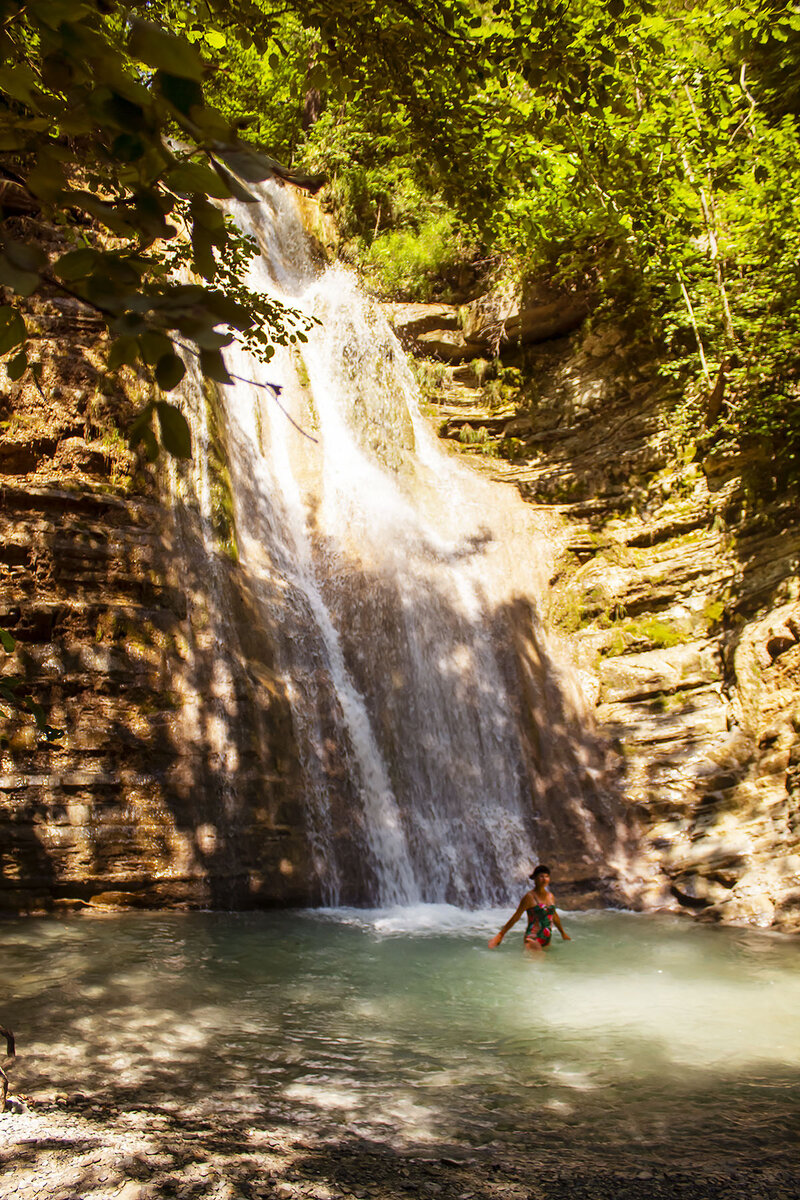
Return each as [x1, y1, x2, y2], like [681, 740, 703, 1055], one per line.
[0, 258, 800, 930]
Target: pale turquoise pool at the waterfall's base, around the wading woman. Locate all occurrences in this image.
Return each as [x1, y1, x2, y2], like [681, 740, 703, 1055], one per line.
[0, 906, 800, 1156]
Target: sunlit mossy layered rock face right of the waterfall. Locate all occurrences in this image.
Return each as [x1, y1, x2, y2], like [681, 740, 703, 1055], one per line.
[392, 296, 800, 930]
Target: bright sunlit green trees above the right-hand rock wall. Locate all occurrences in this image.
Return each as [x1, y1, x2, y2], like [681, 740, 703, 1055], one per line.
[272, 0, 800, 487]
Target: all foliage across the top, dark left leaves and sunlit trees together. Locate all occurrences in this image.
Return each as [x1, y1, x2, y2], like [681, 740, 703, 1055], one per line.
[0, 0, 800, 475]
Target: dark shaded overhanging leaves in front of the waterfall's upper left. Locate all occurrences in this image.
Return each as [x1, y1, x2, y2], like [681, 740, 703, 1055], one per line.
[0, 0, 316, 455]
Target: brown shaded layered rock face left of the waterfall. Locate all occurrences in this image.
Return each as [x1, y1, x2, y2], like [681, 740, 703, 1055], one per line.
[0, 297, 315, 911]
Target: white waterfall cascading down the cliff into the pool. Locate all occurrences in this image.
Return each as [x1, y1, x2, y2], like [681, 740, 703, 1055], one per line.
[176, 186, 614, 906]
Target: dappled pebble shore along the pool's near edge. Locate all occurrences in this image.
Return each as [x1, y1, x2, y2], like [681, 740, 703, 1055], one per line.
[0, 1094, 800, 1200]
